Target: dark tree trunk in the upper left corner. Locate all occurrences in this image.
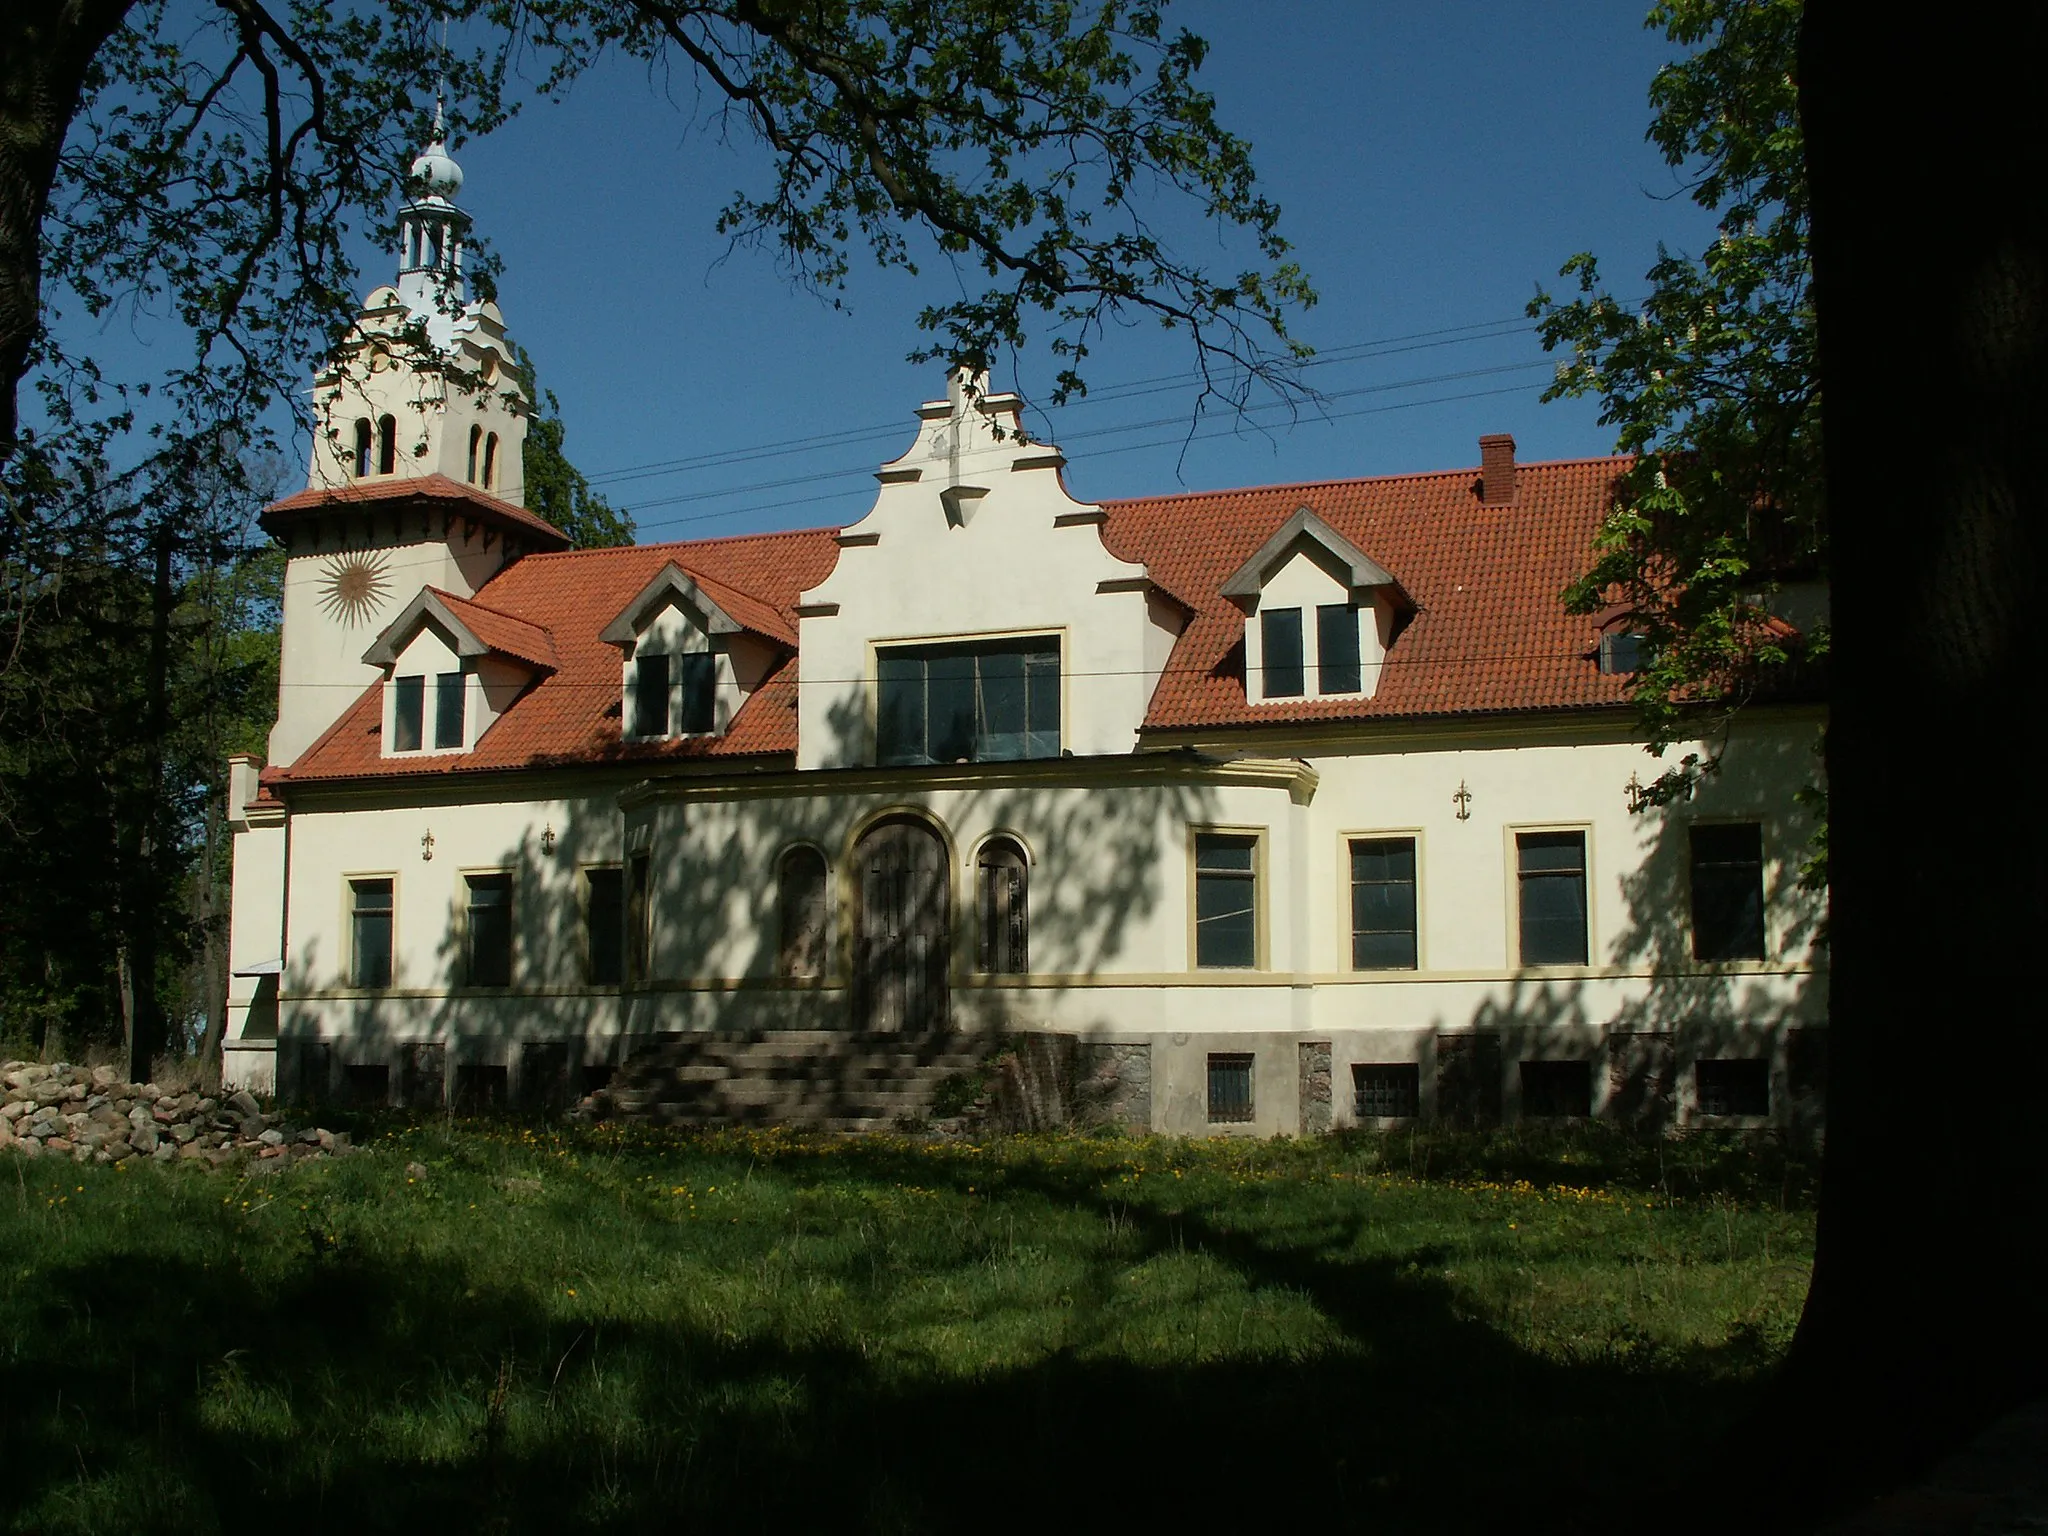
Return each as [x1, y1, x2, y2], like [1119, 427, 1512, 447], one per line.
[0, 0, 133, 450]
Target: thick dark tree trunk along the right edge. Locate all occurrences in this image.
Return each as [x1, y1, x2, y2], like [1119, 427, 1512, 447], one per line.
[1777, 0, 2048, 1513]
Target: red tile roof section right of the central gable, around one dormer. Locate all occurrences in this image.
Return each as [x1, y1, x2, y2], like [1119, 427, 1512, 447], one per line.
[1102, 459, 1630, 731]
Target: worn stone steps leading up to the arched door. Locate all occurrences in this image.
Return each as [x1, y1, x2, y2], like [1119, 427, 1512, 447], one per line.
[580, 1030, 999, 1130]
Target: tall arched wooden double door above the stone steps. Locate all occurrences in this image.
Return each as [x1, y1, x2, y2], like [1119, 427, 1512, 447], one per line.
[854, 817, 952, 1034]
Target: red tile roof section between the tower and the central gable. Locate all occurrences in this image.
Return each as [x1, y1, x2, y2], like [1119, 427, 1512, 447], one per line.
[278, 528, 840, 784]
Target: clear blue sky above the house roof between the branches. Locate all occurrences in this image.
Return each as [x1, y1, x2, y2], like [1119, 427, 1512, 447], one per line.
[79, 0, 1708, 541]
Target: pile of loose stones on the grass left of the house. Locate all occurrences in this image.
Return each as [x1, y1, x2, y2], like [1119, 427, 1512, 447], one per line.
[0, 1061, 350, 1169]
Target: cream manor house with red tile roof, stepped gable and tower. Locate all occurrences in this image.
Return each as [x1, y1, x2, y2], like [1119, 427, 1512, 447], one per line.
[225, 145, 1827, 1135]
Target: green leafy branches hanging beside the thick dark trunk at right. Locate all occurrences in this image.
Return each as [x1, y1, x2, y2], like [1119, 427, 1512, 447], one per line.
[1530, 0, 1827, 805]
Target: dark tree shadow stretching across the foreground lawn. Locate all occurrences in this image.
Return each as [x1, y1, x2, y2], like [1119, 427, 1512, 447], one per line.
[0, 1122, 1794, 1532]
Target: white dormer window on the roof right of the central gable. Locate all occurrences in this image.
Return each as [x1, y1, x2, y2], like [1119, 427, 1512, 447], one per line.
[1223, 508, 1413, 705]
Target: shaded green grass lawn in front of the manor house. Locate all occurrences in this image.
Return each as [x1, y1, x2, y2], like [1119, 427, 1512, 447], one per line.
[0, 1120, 1812, 1536]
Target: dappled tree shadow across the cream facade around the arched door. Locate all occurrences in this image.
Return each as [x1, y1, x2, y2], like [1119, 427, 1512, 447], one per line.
[279, 692, 1220, 1110]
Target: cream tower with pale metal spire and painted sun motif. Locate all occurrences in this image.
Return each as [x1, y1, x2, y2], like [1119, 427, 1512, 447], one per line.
[262, 123, 569, 768]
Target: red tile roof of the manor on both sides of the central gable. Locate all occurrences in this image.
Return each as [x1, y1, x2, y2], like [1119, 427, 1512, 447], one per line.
[266, 459, 1628, 782]
